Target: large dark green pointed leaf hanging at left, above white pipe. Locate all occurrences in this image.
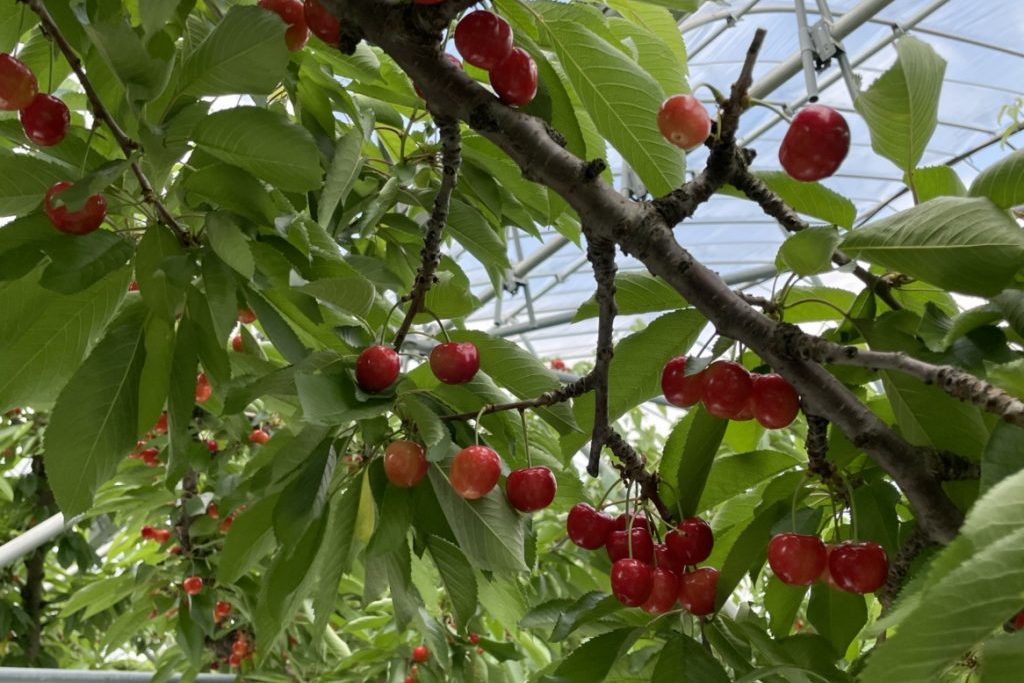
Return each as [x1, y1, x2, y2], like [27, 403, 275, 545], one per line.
[44, 302, 145, 517]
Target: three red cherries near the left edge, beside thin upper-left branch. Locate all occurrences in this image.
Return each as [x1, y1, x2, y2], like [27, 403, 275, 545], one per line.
[0, 53, 106, 234]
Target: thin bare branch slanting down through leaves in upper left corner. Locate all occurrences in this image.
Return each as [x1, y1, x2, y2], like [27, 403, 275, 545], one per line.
[18, 0, 194, 247]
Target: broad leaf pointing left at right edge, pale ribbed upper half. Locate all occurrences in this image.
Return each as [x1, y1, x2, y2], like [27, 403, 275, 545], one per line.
[842, 197, 1024, 296]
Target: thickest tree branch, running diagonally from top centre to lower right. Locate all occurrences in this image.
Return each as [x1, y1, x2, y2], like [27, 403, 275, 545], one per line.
[324, 0, 963, 543]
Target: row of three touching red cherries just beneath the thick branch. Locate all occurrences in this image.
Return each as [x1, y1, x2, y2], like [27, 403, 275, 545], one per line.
[662, 356, 800, 429]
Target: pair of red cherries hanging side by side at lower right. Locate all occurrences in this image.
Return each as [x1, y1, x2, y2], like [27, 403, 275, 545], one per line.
[768, 533, 889, 595]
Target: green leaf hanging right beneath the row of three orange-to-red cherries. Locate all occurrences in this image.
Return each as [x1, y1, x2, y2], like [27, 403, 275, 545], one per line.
[429, 466, 526, 571]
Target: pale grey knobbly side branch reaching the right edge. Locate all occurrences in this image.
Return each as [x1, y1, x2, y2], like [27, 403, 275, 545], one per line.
[783, 326, 1024, 427]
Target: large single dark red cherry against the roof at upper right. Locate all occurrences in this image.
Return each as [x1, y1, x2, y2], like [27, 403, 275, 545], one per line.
[778, 104, 850, 182]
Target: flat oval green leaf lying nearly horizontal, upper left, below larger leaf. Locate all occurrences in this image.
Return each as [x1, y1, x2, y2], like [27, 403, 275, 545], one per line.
[193, 106, 323, 193]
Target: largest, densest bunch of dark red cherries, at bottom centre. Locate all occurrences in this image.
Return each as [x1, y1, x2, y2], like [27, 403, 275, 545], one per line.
[565, 503, 719, 616]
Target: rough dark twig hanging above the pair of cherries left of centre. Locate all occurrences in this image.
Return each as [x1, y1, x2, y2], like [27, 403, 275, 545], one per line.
[394, 116, 462, 349]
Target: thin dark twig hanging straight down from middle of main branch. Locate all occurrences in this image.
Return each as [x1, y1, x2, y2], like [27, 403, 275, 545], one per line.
[584, 232, 618, 476]
